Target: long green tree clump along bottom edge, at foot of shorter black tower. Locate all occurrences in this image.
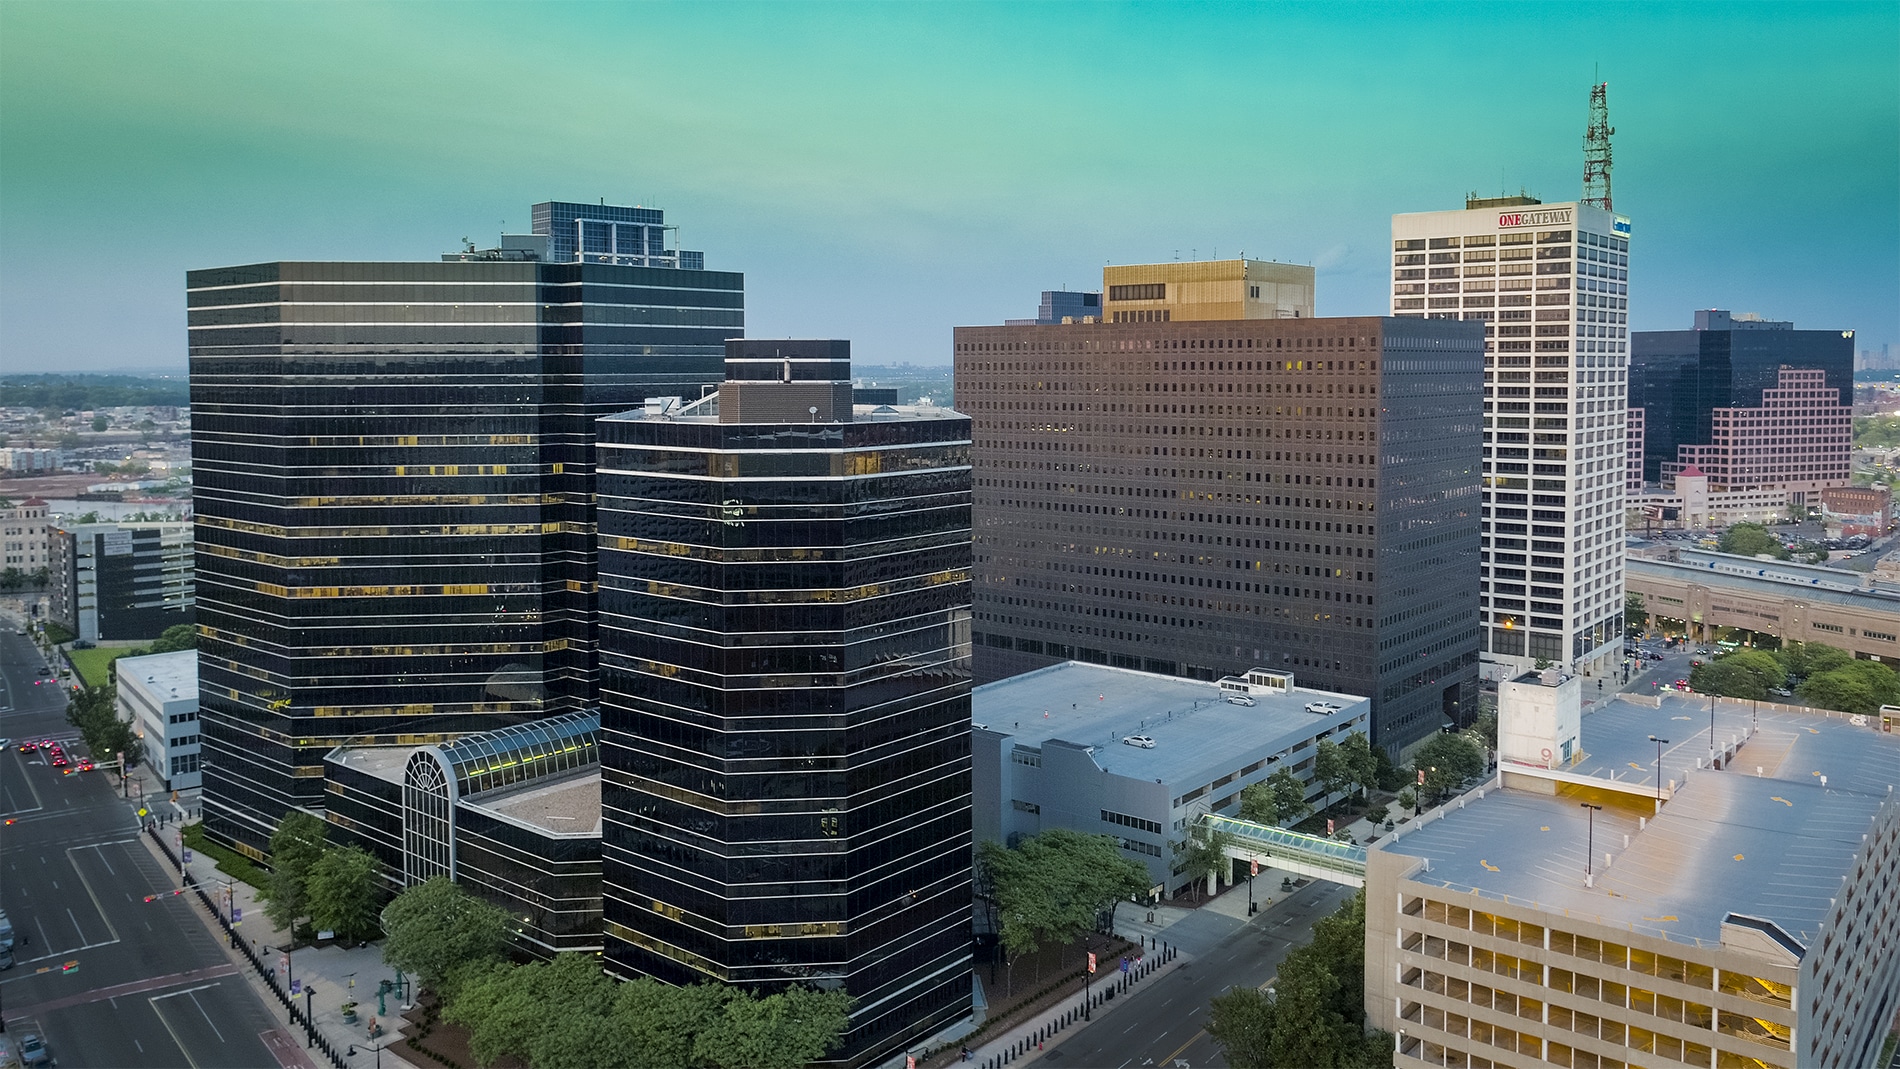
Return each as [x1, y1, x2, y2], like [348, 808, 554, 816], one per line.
[443, 953, 851, 1069]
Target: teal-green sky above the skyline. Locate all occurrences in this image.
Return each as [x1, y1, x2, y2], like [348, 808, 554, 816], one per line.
[0, 0, 1900, 370]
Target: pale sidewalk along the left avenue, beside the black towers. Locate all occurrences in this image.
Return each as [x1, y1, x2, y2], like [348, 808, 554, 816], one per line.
[133, 767, 414, 1069]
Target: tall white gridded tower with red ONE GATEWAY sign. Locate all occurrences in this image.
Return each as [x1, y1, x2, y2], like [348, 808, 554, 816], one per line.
[1393, 197, 1630, 680]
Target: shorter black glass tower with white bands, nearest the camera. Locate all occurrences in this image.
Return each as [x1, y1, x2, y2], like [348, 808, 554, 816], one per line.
[599, 342, 971, 1065]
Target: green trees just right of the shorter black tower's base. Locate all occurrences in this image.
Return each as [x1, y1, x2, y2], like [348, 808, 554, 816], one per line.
[977, 828, 1150, 987]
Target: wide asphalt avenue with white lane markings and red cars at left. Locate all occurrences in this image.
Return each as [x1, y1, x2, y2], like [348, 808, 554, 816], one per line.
[0, 621, 283, 1069]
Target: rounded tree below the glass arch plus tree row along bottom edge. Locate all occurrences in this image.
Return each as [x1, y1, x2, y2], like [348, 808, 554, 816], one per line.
[382, 877, 851, 1069]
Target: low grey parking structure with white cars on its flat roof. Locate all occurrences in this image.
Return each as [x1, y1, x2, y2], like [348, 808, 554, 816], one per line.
[971, 661, 1372, 894]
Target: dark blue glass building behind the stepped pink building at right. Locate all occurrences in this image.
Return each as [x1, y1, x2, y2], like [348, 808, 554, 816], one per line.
[1630, 309, 1854, 482]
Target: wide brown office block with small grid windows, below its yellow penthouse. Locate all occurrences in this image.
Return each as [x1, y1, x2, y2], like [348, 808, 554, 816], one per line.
[956, 317, 1484, 750]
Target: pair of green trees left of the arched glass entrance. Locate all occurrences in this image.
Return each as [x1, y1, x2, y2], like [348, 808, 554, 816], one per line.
[258, 809, 382, 944]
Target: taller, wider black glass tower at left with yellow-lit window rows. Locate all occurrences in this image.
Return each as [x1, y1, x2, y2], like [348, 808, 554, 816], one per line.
[186, 258, 745, 849]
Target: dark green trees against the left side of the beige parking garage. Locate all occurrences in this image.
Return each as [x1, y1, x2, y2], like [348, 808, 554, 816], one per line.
[1207, 889, 1393, 1069]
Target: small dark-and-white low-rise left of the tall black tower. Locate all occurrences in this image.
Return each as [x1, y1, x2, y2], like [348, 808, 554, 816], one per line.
[48, 520, 198, 642]
